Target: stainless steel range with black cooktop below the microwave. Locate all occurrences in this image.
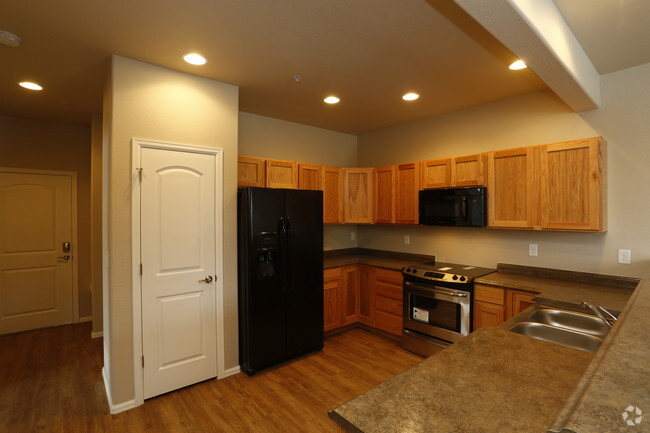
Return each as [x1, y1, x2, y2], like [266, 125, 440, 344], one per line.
[402, 262, 496, 356]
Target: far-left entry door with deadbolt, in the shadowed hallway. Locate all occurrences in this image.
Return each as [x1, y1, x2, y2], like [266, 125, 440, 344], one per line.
[0, 172, 74, 334]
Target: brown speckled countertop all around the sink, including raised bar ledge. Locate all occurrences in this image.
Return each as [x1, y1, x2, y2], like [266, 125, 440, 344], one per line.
[329, 264, 650, 433]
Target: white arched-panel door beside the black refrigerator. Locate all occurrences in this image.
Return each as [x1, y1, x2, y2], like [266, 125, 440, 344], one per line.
[140, 148, 221, 398]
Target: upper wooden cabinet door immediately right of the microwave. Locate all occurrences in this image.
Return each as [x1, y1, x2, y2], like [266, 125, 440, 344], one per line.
[488, 147, 537, 229]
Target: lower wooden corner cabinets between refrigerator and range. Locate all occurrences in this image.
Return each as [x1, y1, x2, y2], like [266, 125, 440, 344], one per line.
[323, 265, 402, 335]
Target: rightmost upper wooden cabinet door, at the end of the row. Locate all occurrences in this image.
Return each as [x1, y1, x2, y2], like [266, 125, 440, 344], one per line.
[540, 137, 606, 231]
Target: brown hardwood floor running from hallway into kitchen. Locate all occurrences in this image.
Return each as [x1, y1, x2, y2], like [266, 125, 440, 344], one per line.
[0, 323, 422, 433]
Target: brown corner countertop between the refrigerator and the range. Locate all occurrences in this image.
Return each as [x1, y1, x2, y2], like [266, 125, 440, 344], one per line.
[323, 248, 436, 271]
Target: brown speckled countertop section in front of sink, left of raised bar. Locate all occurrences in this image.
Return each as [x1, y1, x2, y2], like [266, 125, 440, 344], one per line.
[329, 328, 593, 433]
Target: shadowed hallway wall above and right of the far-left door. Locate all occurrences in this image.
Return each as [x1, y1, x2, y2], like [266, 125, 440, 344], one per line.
[0, 116, 92, 319]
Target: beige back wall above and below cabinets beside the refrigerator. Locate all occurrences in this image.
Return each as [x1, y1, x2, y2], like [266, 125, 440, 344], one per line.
[239, 112, 357, 250]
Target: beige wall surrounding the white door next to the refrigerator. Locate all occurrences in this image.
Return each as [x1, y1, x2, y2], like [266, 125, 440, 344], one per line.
[104, 56, 239, 404]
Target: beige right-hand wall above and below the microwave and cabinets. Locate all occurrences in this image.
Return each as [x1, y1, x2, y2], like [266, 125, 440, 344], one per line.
[358, 60, 650, 276]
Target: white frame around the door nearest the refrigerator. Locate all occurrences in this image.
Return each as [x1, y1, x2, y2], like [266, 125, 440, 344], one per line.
[131, 137, 226, 406]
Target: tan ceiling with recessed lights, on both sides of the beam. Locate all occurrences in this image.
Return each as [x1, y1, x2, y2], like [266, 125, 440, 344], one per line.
[0, 0, 650, 134]
